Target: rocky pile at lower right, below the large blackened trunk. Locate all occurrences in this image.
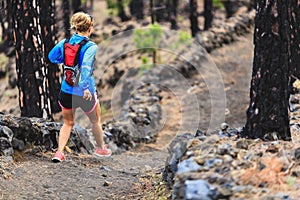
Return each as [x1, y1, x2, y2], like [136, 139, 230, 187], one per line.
[163, 90, 300, 200]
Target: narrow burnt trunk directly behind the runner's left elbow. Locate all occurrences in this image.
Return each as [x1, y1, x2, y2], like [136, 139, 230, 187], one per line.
[40, 0, 61, 113]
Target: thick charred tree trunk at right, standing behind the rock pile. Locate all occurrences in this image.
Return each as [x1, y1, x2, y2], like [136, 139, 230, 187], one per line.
[243, 0, 299, 140]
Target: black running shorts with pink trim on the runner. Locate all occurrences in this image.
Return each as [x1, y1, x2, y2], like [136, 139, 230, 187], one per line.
[58, 91, 98, 114]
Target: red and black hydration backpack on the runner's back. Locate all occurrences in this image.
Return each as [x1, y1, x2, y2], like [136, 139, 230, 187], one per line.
[63, 38, 88, 86]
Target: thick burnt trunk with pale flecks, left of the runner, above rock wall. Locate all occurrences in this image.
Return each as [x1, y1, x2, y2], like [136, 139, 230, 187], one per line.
[12, 0, 51, 118]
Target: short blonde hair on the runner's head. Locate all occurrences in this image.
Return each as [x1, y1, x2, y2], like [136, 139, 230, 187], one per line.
[71, 12, 94, 32]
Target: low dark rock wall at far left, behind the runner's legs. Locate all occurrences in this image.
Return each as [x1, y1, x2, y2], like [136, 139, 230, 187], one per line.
[0, 115, 94, 156]
